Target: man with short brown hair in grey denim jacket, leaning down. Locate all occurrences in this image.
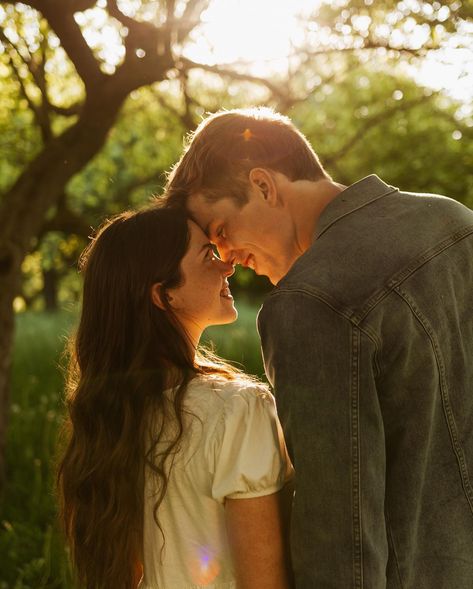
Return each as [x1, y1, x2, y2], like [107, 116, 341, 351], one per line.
[167, 109, 473, 589]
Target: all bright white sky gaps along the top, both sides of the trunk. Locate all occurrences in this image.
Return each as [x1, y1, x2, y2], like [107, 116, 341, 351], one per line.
[65, 0, 473, 102]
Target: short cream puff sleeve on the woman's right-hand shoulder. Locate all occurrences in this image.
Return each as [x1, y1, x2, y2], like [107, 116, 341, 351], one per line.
[211, 387, 294, 503]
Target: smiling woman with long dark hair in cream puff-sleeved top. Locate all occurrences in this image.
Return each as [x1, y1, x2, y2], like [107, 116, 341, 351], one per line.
[58, 208, 292, 589]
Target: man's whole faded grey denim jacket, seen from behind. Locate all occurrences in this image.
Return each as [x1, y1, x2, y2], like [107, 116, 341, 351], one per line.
[258, 176, 473, 589]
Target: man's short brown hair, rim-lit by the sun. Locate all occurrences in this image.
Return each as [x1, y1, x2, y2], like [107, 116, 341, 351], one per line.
[165, 107, 329, 206]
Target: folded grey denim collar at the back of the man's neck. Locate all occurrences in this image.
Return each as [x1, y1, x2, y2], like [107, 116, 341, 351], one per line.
[314, 174, 399, 240]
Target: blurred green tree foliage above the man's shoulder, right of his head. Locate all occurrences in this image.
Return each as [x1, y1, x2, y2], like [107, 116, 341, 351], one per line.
[291, 68, 473, 206]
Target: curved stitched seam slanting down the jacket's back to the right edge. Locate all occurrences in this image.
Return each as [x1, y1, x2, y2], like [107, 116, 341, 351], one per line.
[396, 287, 473, 514]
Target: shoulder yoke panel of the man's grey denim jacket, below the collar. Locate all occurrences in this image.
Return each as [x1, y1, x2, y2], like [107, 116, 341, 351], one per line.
[268, 185, 473, 314]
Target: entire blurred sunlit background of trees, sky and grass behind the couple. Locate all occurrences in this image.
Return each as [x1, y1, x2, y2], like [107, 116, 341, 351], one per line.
[0, 0, 473, 589]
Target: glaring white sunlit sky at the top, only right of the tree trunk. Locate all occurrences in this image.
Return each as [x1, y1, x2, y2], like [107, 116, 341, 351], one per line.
[180, 0, 473, 102]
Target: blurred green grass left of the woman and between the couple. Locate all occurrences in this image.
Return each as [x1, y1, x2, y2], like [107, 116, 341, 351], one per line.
[0, 302, 263, 589]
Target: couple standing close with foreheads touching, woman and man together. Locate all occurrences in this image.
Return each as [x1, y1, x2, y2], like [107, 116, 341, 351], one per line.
[58, 109, 473, 589]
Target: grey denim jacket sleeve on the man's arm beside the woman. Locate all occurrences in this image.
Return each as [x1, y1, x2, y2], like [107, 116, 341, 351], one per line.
[258, 289, 388, 589]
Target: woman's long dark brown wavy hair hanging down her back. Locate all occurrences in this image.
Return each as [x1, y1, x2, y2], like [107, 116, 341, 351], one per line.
[57, 206, 236, 589]
